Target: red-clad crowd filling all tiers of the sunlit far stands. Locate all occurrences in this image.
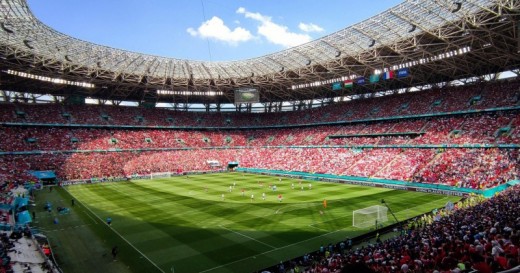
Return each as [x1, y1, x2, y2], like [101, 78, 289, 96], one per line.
[0, 79, 520, 185]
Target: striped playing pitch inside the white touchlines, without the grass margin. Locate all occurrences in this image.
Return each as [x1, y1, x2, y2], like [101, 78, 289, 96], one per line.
[65, 173, 460, 272]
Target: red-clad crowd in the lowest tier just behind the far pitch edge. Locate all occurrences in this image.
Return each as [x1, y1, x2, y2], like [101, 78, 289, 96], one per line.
[0, 144, 520, 189]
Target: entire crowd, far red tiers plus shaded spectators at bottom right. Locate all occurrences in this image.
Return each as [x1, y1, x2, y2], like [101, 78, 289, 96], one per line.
[0, 79, 520, 273]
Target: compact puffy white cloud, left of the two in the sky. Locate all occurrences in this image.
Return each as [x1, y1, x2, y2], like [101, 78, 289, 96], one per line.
[186, 16, 253, 45]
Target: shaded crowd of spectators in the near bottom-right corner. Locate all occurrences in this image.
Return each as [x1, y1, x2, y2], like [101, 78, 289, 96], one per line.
[268, 185, 520, 273]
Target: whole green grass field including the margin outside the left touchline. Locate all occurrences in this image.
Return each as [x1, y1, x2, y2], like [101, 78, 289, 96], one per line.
[36, 173, 458, 273]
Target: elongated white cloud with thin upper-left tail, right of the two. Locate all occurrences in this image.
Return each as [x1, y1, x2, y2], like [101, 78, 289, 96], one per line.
[236, 7, 312, 47]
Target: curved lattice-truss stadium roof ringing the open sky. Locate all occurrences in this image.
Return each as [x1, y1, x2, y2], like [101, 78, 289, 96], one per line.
[0, 0, 520, 103]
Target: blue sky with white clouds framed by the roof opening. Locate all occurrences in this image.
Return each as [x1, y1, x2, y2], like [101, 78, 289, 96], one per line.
[28, 0, 402, 61]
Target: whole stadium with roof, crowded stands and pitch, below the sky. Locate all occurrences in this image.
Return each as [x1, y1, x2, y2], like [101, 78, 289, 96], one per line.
[0, 0, 520, 273]
